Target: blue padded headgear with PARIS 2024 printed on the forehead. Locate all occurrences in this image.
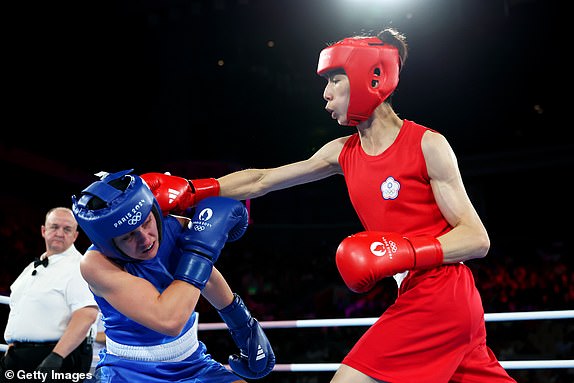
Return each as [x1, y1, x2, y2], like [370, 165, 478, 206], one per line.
[72, 169, 162, 262]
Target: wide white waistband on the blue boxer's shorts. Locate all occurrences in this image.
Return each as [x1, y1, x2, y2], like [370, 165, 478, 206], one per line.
[106, 319, 199, 362]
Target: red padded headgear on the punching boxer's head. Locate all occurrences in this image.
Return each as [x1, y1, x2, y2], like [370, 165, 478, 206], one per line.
[317, 37, 400, 126]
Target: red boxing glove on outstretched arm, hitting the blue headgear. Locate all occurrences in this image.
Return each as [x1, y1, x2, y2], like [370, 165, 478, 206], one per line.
[140, 173, 219, 215]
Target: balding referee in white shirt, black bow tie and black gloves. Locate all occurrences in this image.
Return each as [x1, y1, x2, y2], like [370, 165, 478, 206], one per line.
[0, 207, 99, 383]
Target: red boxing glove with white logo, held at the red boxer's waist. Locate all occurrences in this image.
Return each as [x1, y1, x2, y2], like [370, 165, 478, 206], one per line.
[336, 231, 443, 293]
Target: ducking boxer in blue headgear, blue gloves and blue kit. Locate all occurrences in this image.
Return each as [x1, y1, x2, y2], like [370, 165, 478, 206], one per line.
[72, 170, 275, 383]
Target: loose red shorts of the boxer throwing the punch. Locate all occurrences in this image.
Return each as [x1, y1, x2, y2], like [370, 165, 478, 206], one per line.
[342, 264, 516, 383]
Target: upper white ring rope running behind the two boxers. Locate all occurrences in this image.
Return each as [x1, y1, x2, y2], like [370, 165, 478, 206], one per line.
[199, 310, 574, 330]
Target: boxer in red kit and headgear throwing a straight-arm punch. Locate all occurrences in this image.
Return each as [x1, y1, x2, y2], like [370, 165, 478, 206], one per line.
[142, 28, 515, 383]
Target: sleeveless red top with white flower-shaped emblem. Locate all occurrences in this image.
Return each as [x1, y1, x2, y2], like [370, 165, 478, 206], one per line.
[339, 120, 452, 237]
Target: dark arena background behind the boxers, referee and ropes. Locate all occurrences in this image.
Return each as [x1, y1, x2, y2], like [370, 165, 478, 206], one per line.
[0, 0, 574, 383]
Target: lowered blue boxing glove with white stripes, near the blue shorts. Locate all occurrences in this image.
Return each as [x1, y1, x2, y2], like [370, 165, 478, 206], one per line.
[218, 294, 275, 379]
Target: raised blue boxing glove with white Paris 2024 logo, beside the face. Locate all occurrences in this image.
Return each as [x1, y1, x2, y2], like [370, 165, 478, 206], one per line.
[174, 197, 248, 290]
